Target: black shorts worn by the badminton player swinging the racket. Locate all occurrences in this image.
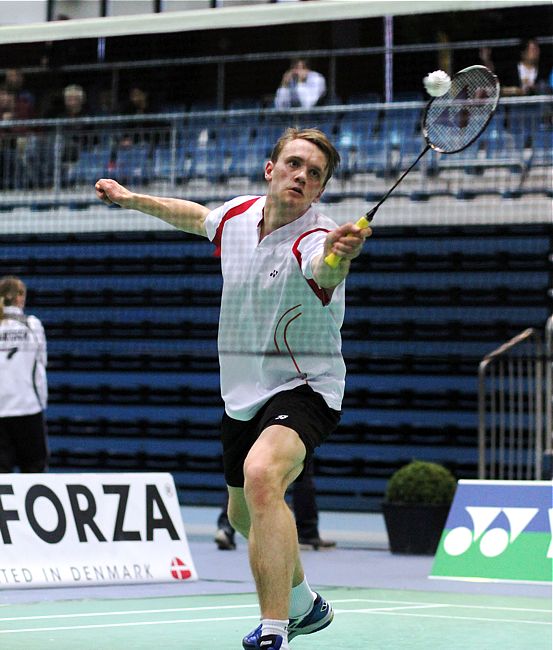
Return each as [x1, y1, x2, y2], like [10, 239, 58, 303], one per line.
[221, 386, 341, 487]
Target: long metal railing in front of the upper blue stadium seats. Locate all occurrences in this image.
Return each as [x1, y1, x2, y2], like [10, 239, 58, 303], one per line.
[0, 97, 552, 203]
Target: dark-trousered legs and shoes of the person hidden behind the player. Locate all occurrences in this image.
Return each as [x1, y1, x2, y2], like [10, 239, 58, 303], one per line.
[215, 462, 336, 551]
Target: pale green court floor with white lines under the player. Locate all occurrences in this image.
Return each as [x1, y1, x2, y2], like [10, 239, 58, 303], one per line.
[0, 587, 552, 650]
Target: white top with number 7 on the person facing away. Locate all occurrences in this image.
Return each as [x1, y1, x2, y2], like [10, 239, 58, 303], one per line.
[0, 307, 48, 418]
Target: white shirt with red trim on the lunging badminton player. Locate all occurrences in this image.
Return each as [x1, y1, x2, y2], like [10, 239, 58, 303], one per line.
[205, 196, 346, 420]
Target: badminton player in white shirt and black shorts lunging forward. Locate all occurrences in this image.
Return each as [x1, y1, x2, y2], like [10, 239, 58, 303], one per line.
[96, 129, 371, 650]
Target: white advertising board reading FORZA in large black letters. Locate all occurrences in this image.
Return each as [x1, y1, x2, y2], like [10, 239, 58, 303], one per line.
[0, 473, 198, 589]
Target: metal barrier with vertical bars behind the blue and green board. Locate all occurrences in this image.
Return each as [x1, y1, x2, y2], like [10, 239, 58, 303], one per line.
[478, 317, 553, 480]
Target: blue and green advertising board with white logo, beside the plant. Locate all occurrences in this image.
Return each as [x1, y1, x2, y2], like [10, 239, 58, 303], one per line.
[430, 481, 553, 583]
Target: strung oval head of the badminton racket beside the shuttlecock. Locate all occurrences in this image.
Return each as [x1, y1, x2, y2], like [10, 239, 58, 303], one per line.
[422, 65, 500, 153]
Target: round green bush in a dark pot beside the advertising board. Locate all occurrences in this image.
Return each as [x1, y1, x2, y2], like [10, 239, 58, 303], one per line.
[382, 460, 457, 555]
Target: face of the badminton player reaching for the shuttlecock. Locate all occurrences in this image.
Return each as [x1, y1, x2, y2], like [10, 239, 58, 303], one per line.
[265, 138, 328, 217]
